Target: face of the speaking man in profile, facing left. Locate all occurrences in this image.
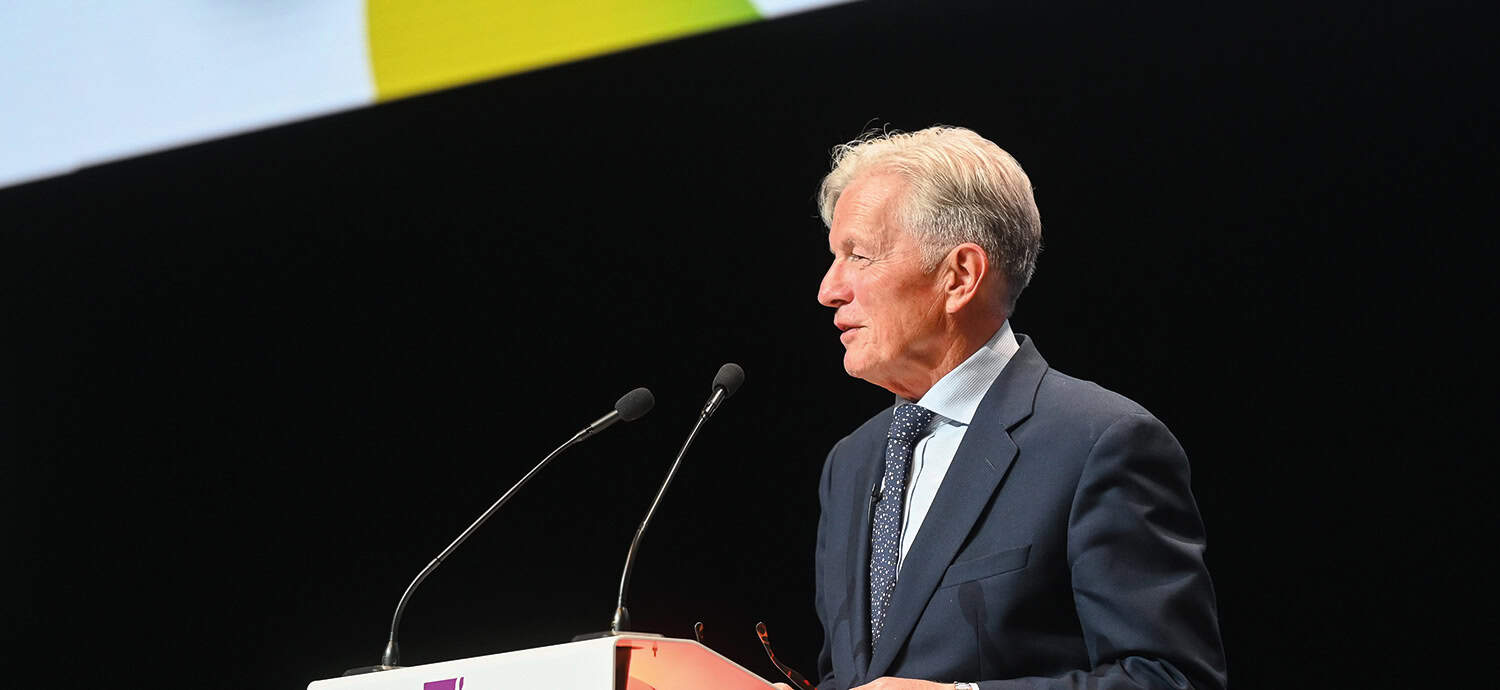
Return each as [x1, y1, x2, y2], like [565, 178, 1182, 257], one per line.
[818, 174, 944, 399]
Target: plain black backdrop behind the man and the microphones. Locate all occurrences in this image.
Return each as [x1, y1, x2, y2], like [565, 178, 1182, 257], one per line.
[0, 2, 1496, 689]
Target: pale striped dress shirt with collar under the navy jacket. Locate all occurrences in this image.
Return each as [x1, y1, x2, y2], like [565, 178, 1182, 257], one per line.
[896, 320, 1020, 572]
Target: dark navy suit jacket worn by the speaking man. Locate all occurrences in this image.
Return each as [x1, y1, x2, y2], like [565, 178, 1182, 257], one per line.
[816, 336, 1226, 690]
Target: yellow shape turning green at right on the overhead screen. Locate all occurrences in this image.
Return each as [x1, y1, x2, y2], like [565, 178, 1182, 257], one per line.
[366, 0, 761, 101]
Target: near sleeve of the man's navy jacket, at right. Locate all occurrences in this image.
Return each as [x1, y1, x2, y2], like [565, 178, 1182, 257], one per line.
[980, 413, 1227, 690]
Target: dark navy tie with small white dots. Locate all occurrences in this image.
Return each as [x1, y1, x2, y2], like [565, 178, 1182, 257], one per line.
[870, 404, 936, 653]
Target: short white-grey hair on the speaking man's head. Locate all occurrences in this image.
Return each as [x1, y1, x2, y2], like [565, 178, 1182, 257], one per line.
[818, 126, 1041, 314]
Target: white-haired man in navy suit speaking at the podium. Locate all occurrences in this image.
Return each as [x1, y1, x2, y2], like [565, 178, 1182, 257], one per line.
[792, 128, 1226, 690]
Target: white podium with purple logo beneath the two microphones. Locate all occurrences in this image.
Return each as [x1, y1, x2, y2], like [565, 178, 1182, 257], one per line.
[308, 633, 771, 690]
